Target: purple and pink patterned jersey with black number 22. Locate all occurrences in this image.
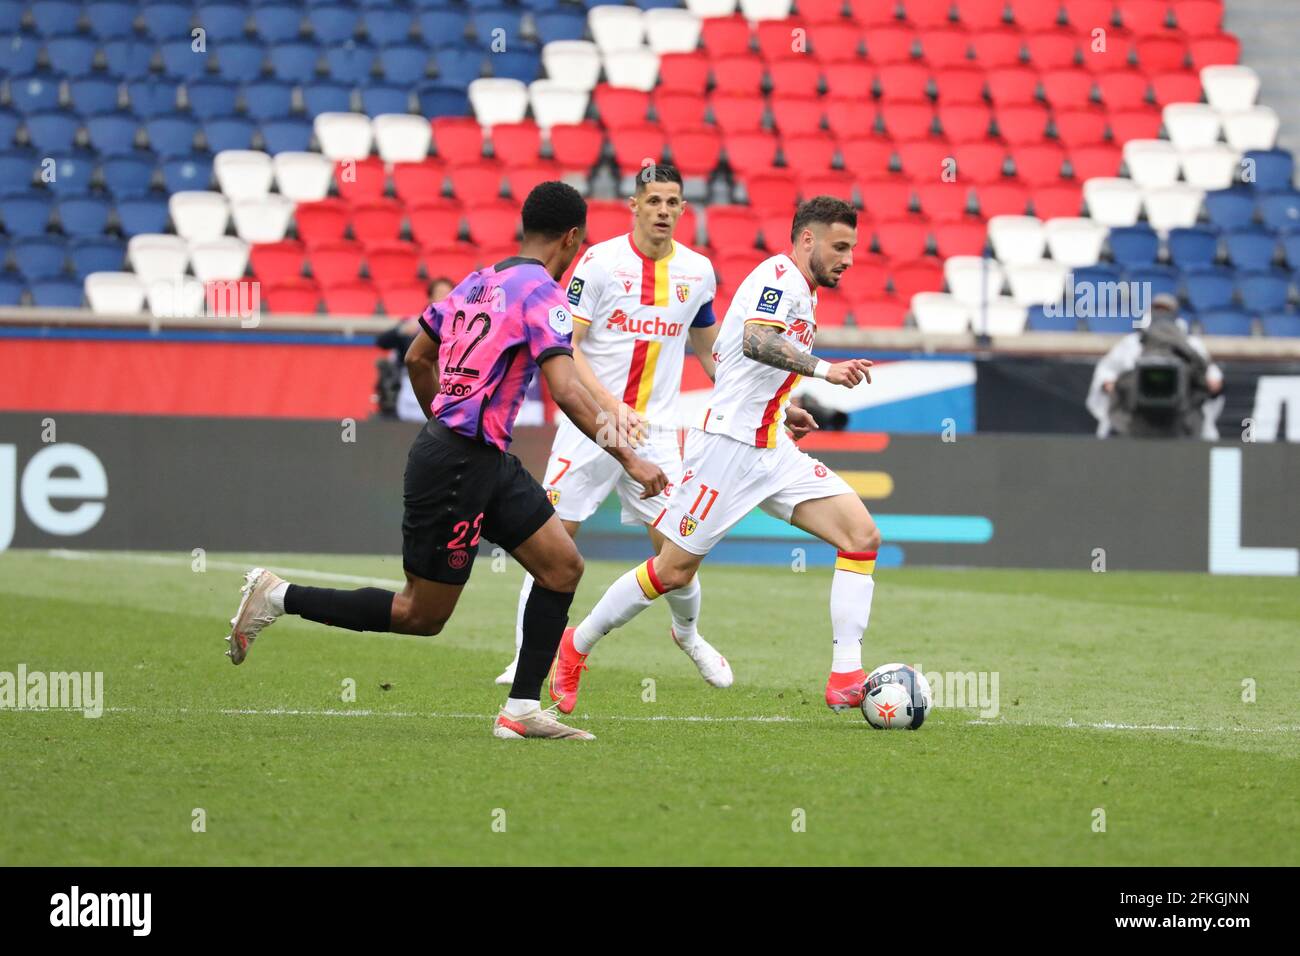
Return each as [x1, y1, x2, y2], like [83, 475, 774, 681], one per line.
[420, 256, 573, 451]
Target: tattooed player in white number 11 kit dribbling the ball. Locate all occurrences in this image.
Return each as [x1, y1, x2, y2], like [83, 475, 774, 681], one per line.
[550, 196, 880, 713]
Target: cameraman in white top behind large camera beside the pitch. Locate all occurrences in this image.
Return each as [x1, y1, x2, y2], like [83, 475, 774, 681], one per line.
[1087, 293, 1223, 441]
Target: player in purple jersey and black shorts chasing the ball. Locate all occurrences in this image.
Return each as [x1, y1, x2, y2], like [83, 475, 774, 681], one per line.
[226, 182, 668, 740]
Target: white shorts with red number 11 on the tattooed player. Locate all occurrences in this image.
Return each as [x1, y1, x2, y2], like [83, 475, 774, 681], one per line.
[654, 428, 854, 554]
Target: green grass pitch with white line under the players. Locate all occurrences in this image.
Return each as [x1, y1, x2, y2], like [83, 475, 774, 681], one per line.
[0, 551, 1300, 865]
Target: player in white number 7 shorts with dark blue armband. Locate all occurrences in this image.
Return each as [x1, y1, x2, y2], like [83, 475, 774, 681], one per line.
[497, 165, 732, 697]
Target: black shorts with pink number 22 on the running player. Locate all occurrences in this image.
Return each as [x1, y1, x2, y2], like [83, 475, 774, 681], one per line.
[402, 419, 555, 584]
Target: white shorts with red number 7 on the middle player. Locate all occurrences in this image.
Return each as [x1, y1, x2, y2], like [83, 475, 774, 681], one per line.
[542, 419, 681, 524]
